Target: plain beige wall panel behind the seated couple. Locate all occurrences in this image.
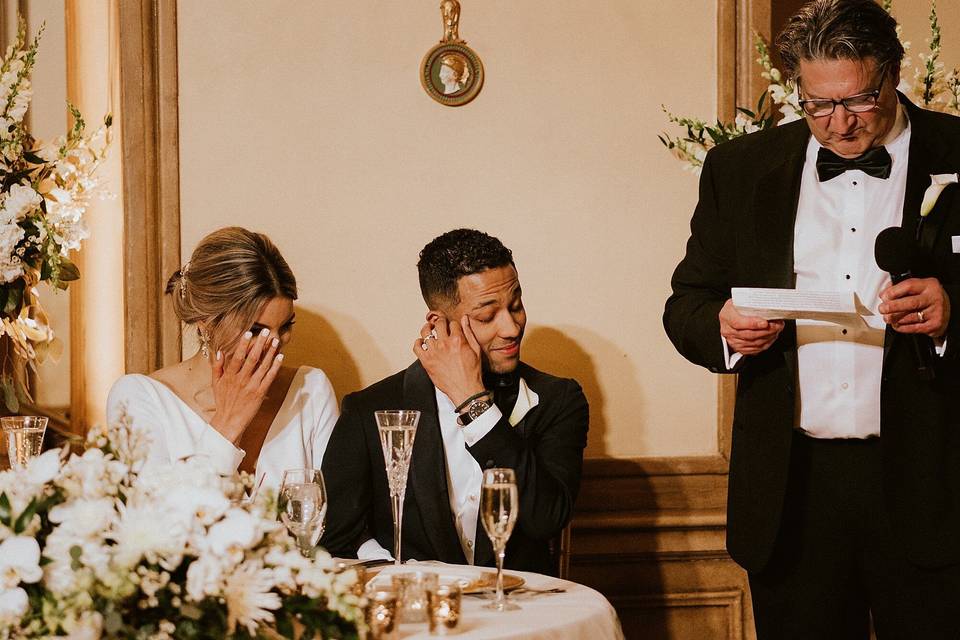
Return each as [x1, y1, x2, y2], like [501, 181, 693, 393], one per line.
[178, 0, 716, 456]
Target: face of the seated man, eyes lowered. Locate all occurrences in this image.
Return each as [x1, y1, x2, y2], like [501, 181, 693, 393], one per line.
[447, 265, 527, 373]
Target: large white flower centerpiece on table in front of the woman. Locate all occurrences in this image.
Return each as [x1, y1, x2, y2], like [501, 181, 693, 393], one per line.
[0, 412, 362, 640]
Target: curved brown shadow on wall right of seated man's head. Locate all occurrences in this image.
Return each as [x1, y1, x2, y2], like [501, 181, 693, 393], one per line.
[523, 327, 642, 458]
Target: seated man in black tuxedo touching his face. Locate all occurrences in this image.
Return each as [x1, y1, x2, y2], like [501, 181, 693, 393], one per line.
[321, 229, 588, 573]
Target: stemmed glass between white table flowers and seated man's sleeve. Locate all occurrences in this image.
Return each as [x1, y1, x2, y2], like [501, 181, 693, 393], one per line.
[277, 469, 327, 558]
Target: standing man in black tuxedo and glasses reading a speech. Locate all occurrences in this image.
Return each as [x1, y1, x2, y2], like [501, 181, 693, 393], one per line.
[664, 0, 960, 640]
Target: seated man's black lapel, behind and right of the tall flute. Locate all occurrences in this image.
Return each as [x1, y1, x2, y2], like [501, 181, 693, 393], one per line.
[403, 362, 465, 562]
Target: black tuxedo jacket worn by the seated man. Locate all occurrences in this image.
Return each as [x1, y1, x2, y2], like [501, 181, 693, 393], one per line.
[321, 362, 589, 573]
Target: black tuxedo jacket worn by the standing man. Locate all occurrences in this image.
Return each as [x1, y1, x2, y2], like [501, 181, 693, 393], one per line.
[663, 96, 960, 571]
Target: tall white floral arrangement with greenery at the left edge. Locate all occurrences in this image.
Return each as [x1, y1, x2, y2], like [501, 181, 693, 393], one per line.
[0, 20, 110, 412]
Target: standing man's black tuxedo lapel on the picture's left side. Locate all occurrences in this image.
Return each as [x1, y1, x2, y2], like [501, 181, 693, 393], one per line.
[751, 122, 810, 289]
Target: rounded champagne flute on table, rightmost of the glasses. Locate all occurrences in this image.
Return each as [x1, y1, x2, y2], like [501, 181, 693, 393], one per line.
[480, 469, 520, 611]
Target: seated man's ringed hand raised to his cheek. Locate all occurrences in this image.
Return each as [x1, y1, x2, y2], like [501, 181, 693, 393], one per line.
[413, 315, 483, 406]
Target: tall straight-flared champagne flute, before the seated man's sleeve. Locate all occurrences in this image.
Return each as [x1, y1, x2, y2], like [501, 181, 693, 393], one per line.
[374, 410, 420, 565]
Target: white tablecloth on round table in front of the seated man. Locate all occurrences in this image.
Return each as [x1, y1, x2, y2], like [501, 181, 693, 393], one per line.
[368, 562, 623, 640]
